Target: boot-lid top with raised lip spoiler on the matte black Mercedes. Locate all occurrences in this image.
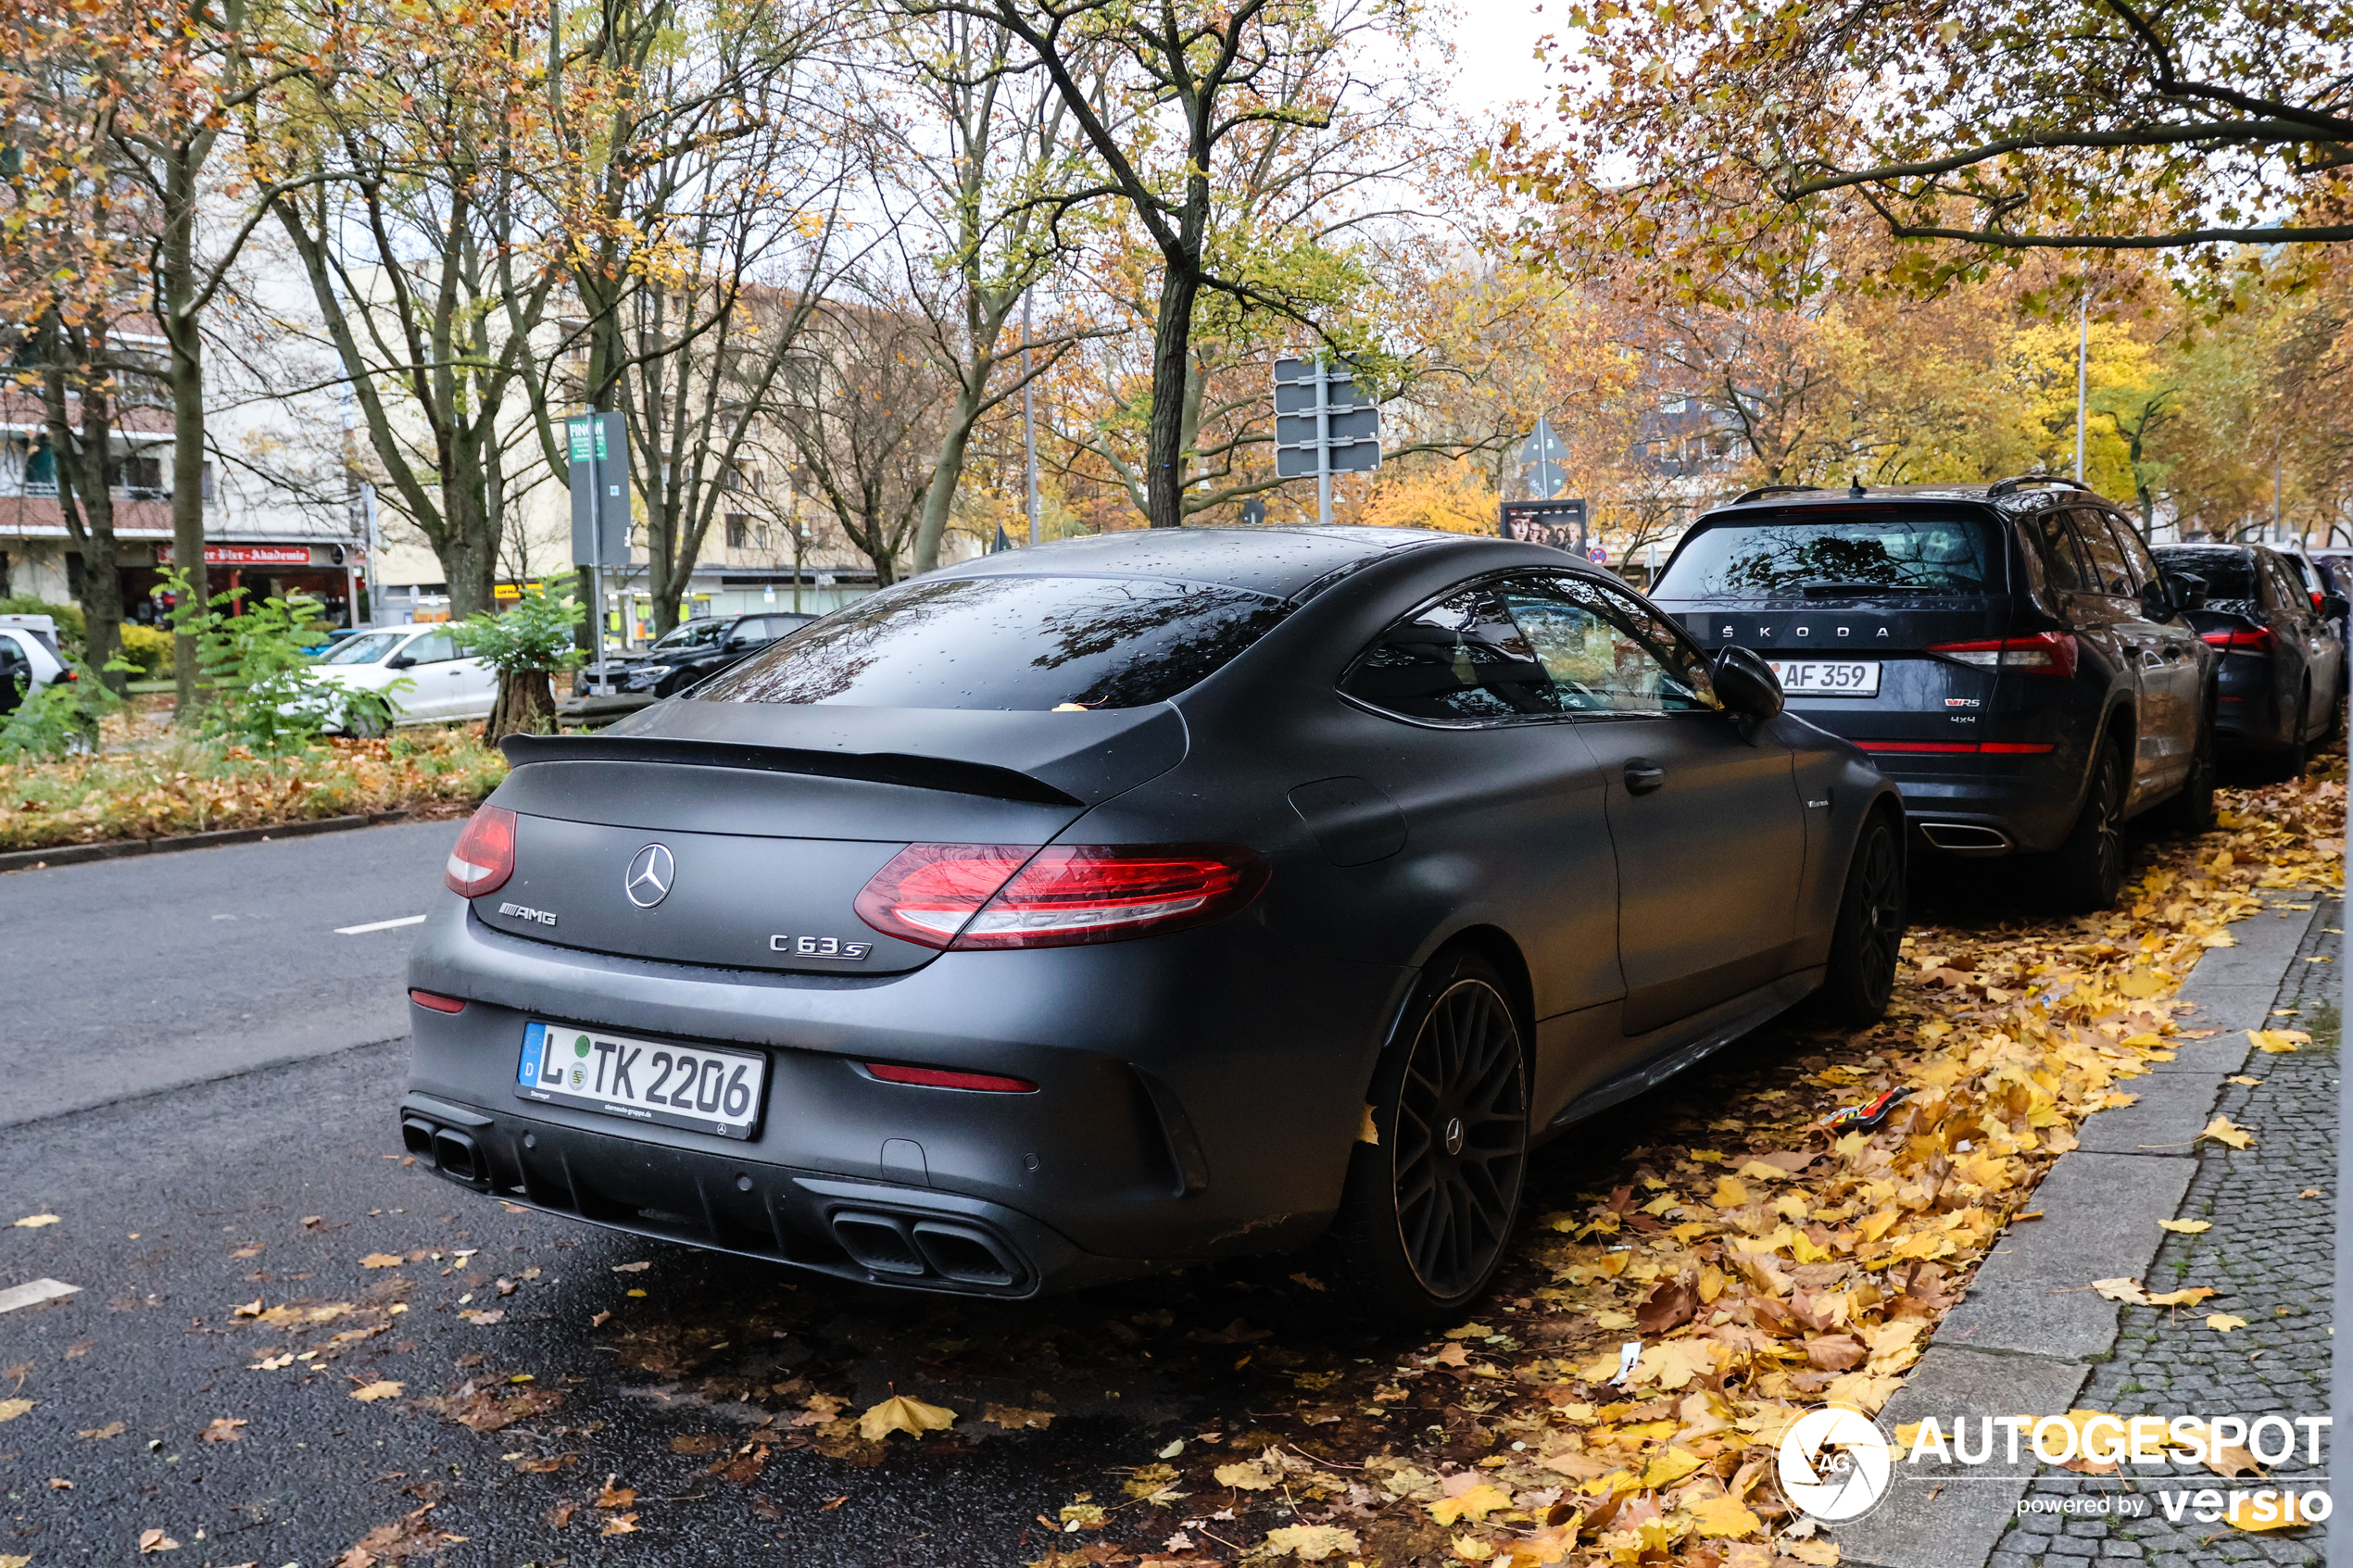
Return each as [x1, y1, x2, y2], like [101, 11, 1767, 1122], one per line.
[498, 698, 1186, 807]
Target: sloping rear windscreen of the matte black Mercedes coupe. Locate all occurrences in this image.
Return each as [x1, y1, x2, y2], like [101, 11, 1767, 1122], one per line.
[697, 576, 1291, 712]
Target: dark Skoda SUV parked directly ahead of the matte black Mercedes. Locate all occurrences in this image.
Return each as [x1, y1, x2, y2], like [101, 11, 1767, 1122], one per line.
[1652, 475, 2214, 909]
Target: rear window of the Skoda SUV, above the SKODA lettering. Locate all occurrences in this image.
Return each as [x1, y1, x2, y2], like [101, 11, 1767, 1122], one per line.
[1656, 506, 1993, 599]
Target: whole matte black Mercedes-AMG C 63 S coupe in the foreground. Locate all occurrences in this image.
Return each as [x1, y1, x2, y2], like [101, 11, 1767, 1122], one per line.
[400, 529, 1904, 1316]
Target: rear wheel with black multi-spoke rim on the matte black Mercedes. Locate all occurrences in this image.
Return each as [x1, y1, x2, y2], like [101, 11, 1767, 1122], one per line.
[1332, 952, 1527, 1326]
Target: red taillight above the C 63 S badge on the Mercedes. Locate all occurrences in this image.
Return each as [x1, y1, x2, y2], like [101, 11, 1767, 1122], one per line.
[857, 844, 1266, 949]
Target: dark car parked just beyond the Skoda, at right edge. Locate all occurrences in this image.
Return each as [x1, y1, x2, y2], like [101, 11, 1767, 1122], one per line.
[2156, 546, 2346, 778]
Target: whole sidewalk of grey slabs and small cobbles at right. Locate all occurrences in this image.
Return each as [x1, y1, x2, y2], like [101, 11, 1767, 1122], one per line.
[1835, 894, 2344, 1568]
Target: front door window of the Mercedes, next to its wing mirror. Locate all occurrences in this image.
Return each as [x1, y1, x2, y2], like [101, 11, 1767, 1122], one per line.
[1502, 576, 1716, 712]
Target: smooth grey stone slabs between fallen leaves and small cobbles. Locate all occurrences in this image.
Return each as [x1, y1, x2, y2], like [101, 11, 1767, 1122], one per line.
[1831, 896, 2341, 1568]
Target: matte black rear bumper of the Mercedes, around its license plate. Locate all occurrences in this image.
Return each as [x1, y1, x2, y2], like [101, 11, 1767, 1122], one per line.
[402, 896, 1415, 1296]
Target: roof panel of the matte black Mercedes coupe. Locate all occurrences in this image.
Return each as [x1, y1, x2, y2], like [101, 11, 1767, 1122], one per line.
[937, 527, 1458, 599]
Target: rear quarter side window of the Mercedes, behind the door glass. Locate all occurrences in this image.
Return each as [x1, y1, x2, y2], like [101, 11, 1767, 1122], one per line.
[1339, 583, 1560, 724]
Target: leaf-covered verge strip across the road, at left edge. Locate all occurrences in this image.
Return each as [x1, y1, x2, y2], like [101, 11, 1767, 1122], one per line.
[0, 726, 506, 848]
